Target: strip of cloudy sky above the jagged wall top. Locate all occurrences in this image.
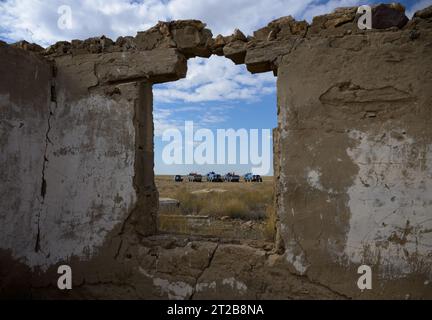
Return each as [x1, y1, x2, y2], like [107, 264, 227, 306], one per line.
[0, 0, 400, 46]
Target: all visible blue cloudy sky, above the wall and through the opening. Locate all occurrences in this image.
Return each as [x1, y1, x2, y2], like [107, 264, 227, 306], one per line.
[0, 0, 432, 174]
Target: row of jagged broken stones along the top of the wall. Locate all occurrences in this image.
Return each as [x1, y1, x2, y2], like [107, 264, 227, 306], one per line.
[13, 3, 432, 74]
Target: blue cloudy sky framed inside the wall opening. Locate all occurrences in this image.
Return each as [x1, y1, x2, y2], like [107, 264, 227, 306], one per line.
[153, 56, 277, 174]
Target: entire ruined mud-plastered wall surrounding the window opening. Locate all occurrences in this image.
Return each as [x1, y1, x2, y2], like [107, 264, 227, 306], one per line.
[0, 5, 432, 299]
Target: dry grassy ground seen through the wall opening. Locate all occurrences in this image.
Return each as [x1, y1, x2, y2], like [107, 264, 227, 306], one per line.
[156, 176, 275, 241]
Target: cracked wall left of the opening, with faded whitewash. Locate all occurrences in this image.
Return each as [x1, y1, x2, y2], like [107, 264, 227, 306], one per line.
[0, 47, 158, 294]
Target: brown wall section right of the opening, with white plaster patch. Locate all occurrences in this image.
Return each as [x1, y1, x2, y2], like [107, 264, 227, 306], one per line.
[278, 6, 432, 298]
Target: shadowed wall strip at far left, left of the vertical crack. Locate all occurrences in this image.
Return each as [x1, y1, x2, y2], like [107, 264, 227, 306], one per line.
[0, 45, 53, 270]
